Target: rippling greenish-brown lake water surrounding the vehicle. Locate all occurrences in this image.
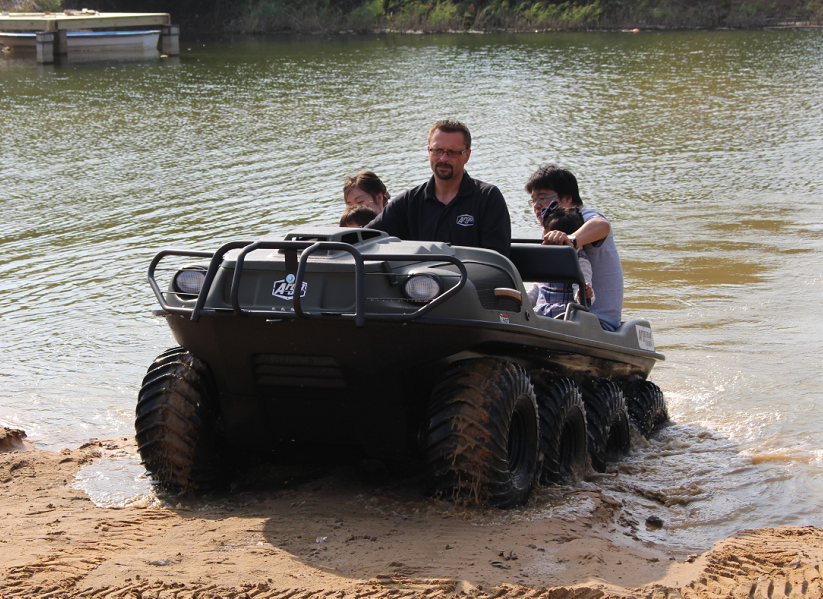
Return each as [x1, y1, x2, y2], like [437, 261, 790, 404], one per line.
[0, 30, 823, 551]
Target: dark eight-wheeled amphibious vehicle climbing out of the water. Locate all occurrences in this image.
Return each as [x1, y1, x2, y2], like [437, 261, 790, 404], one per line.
[140, 228, 667, 507]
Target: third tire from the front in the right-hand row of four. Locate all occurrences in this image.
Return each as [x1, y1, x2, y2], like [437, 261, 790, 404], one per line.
[578, 377, 631, 472]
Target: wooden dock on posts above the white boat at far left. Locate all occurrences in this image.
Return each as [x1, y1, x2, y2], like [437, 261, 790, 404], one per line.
[0, 8, 180, 64]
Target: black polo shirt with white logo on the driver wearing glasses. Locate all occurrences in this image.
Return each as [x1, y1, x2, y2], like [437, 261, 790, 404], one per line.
[366, 172, 512, 256]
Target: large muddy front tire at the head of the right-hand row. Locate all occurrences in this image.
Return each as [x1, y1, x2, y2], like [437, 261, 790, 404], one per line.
[424, 358, 540, 508]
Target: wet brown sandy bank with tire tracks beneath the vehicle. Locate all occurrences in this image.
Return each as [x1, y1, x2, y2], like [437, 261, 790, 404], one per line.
[0, 438, 823, 599]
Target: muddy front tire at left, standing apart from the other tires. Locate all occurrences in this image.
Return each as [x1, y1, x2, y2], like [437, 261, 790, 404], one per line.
[134, 348, 224, 493]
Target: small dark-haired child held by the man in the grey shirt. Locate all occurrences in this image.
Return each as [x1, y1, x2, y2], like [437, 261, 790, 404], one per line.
[529, 206, 594, 318]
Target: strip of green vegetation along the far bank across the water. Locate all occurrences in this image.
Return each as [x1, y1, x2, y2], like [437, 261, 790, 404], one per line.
[0, 0, 823, 33]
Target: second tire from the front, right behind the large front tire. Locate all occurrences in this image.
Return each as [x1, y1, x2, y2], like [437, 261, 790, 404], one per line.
[529, 370, 588, 484]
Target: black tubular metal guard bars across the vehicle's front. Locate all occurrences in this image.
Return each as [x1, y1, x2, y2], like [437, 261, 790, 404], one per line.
[149, 241, 468, 327]
